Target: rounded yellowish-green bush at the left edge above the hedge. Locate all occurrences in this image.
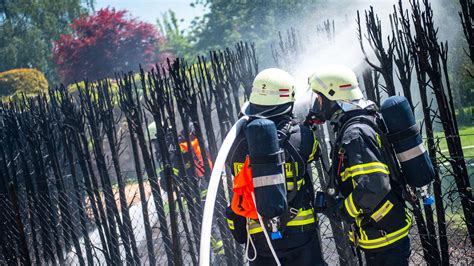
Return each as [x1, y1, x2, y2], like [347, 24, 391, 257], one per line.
[0, 68, 48, 96]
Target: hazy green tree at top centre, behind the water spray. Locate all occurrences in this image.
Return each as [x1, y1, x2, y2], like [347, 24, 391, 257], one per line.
[189, 0, 322, 58]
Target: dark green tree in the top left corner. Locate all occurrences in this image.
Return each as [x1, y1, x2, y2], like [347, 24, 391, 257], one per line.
[0, 0, 91, 81]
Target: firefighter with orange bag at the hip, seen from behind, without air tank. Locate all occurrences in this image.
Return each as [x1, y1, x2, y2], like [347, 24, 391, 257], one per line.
[227, 68, 324, 266]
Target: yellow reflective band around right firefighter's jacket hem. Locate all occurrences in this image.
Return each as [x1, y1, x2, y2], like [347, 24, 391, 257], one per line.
[349, 209, 411, 249]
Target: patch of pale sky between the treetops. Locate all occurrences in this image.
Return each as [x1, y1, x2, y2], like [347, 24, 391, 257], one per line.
[95, 0, 205, 29]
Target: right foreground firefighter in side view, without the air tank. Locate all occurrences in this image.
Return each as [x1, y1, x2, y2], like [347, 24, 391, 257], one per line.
[307, 66, 412, 265]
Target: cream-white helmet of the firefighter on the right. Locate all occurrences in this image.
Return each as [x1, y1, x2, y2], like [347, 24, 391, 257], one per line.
[308, 65, 364, 101]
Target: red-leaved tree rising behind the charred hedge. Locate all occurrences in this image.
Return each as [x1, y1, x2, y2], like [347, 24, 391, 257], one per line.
[53, 8, 170, 84]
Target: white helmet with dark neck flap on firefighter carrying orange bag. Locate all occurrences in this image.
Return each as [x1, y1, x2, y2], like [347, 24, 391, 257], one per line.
[242, 68, 296, 117]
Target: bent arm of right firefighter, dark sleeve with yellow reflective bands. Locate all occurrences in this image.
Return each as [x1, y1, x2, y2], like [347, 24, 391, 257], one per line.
[340, 131, 390, 219]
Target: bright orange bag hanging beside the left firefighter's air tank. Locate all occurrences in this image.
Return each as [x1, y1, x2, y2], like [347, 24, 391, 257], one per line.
[231, 156, 258, 220]
